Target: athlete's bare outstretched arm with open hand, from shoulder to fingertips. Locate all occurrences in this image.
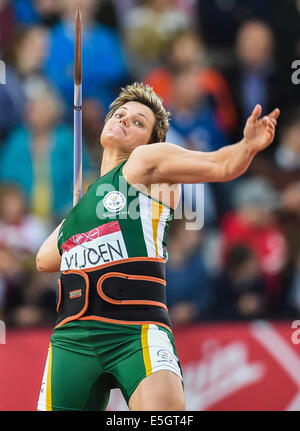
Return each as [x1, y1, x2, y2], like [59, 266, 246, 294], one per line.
[131, 105, 280, 184]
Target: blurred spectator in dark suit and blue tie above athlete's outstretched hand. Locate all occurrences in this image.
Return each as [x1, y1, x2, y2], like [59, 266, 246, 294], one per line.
[225, 20, 285, 146]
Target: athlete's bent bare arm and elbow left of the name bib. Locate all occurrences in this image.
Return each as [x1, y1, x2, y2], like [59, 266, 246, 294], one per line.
[36, 221, 63, 272]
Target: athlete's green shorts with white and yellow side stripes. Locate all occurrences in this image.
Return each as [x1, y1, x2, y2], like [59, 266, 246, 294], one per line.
[38, 320, 182, 411]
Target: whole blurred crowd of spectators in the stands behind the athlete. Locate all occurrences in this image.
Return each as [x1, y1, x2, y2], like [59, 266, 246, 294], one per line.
[0, 0, 300, 327]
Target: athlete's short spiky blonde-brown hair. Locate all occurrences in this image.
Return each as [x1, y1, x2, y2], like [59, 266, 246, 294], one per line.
[105, 82, 170, 144]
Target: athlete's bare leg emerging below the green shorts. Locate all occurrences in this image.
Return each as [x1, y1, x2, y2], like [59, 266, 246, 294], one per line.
[129, 370, 185, 411]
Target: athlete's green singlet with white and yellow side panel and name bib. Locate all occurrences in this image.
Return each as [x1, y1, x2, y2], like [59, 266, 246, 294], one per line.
[58, 160, 174, 271]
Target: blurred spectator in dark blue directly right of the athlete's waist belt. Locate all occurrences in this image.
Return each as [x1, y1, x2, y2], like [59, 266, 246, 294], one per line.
[166, 219, 211, 325]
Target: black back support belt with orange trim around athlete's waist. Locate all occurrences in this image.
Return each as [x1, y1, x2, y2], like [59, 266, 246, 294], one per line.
[55, 257, 171, 329]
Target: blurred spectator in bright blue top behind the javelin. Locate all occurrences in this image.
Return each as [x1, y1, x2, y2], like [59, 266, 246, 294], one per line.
[44, 0, 128, 110]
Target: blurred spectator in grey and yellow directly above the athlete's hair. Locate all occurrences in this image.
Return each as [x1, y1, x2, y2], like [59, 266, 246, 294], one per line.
[123, 0, 192, 80]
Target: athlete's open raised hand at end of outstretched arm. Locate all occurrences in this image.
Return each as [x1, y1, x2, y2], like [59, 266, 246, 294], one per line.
[244, 105, 280, 154]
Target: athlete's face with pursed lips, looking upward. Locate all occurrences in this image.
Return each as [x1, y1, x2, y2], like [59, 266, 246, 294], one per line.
[100, 102, 155, 152]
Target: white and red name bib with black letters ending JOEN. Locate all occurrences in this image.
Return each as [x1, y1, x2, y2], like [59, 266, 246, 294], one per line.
[60, 220, 128, 271]
